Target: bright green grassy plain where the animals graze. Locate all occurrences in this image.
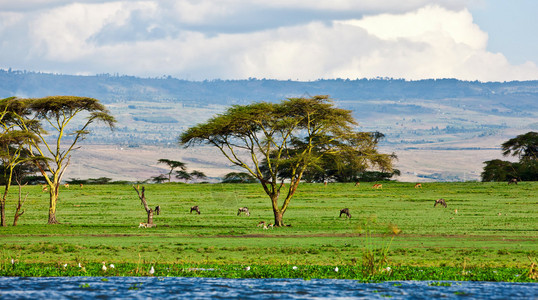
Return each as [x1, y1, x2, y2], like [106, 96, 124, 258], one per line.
[0, 182, 538, 274]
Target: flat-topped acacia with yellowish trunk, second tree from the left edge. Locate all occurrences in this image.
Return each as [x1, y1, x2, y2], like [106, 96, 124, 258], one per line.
[11, 96, 116, 224]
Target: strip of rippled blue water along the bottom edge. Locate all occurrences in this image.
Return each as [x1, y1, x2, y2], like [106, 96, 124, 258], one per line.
[0, 277, 538, 300]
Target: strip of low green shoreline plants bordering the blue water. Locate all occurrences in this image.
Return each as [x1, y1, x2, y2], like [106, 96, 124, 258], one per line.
[0, 260, 537, 282]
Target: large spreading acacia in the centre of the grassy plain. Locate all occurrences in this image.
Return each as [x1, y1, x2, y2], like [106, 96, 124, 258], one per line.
[180, 96, 392, 226]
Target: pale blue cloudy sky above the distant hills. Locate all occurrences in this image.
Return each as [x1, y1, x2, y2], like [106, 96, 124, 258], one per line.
[0, 0, 538, 81]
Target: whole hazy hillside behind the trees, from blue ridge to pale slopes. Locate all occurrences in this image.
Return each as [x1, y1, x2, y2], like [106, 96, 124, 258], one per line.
[0, 69, 538, 180]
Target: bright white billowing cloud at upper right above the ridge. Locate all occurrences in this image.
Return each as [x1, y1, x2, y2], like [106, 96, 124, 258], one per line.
[330, 6, 538, 81]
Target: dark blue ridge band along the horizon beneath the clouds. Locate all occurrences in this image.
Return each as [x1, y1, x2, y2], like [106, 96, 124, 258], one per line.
[0, 69, 538, 107]
